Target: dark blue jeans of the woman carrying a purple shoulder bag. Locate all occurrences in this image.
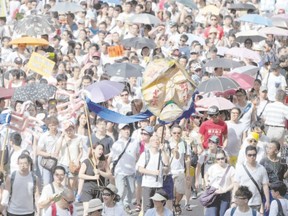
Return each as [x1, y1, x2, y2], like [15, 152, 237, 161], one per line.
[205, 192, 231, 216]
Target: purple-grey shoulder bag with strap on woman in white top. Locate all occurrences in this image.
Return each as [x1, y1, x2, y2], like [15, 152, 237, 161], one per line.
[199, 165, 231, 207]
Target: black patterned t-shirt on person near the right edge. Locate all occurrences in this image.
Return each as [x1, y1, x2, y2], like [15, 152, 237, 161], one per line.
[260, 157, 287, 183]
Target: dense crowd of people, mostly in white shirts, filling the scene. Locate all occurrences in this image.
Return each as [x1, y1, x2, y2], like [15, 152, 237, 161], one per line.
[0, 0, 288, 216]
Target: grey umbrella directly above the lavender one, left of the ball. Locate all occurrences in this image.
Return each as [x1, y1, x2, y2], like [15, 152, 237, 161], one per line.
[105, 63, 144, 78]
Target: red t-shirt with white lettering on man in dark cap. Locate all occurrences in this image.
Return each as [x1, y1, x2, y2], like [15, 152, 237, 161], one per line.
[199, 119, 227, 149]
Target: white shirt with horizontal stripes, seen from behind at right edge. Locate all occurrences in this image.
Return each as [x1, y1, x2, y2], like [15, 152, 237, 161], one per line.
[263, 101, 288, 127]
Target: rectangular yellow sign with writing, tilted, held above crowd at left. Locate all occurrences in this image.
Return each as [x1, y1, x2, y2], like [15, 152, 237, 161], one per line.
[27, 52, 55, 77]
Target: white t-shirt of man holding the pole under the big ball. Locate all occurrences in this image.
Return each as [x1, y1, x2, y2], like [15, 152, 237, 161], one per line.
[136, 150, 163, 188]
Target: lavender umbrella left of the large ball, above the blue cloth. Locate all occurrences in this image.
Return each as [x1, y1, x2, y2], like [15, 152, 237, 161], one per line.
[86, 80, 125, 103]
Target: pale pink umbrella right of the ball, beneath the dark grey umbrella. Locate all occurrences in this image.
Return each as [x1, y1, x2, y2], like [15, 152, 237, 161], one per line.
[196, 97, 235, 110]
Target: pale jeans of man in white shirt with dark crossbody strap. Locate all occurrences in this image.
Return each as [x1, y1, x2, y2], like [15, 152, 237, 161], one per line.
[115, 174, 135, 206]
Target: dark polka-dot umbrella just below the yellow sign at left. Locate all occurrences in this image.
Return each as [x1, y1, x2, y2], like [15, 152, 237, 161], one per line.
[12, 83, 57, 101]
